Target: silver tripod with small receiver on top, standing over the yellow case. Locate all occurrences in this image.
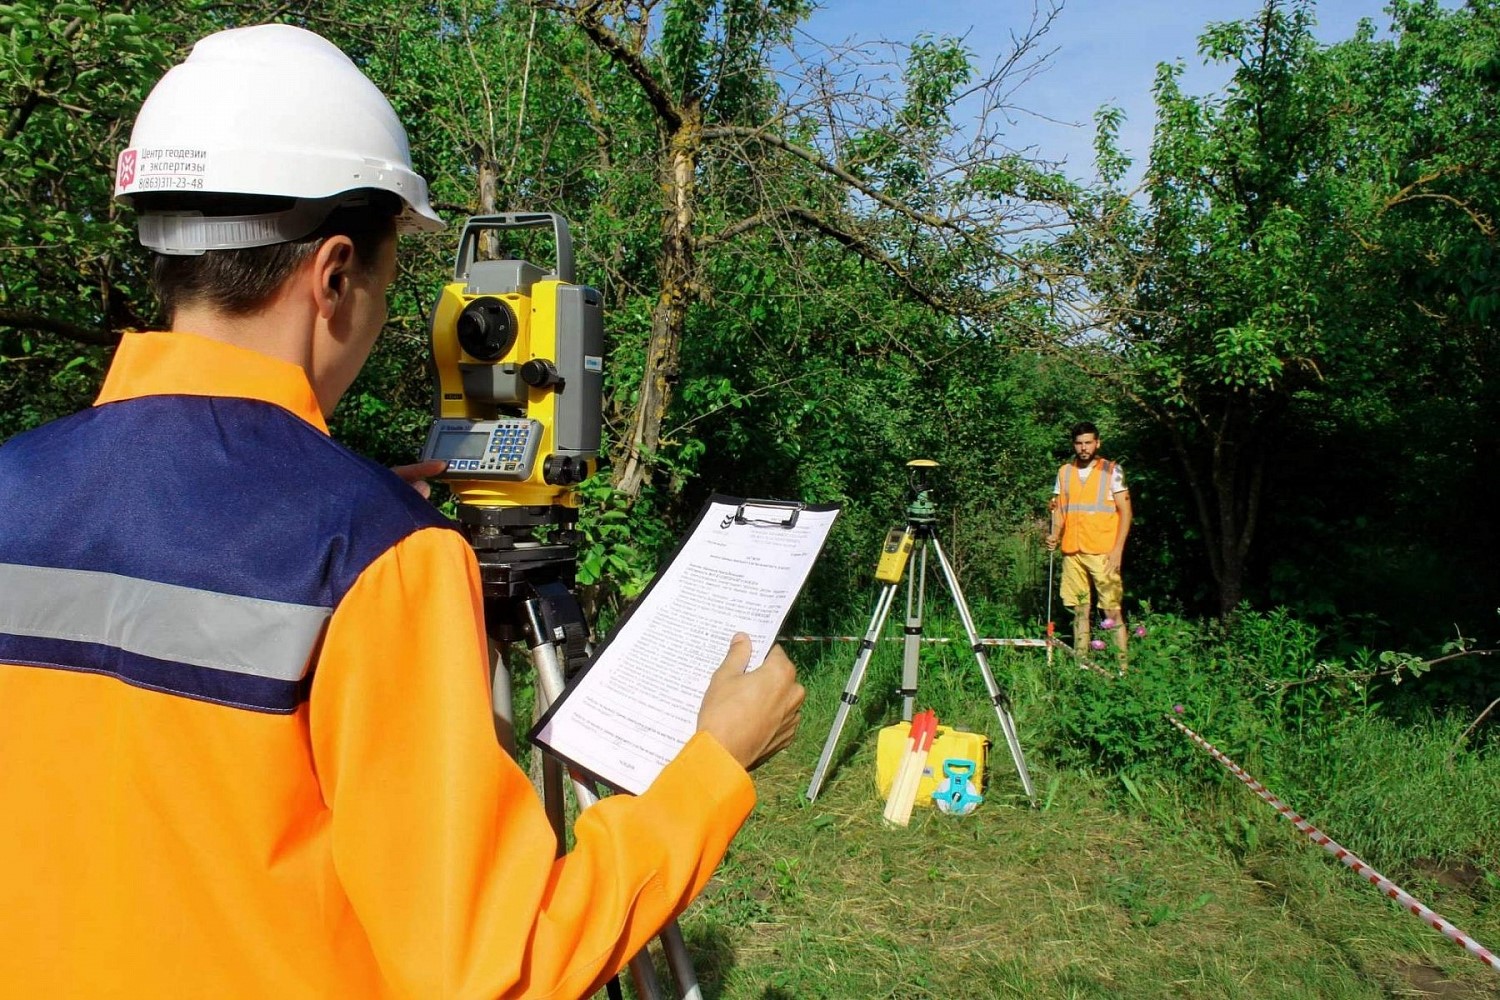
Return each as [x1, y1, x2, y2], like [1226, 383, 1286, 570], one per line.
[807, 459, 1037, 807]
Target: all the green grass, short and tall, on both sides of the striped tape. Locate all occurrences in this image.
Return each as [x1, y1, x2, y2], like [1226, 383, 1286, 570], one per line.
[618, 624, 1500, 1000]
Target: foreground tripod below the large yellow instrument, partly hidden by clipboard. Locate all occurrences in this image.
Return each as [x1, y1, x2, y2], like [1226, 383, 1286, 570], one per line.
[458, 502, 702, 1000]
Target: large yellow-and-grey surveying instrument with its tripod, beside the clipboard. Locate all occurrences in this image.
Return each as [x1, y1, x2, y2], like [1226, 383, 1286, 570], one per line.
[422, 213, 702, 1000]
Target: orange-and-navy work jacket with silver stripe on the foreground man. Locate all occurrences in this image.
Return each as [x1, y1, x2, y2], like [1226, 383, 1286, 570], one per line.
[0, 333, 755, 1000]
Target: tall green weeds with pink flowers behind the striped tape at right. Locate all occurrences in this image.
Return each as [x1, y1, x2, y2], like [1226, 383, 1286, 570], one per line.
[1037, 609, 1500, 868]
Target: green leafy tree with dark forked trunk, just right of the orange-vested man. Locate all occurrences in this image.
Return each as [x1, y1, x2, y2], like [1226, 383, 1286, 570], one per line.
[1100, 0, 1386, 615]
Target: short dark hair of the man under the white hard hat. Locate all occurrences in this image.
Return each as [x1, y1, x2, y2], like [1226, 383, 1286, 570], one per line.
[137, 190, 401, 321]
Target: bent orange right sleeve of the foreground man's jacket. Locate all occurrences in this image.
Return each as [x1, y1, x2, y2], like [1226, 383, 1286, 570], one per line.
[309, 529, 755, 997]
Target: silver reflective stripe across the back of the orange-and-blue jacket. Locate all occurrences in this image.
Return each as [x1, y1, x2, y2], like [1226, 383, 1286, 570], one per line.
[0, 564, 332, 681]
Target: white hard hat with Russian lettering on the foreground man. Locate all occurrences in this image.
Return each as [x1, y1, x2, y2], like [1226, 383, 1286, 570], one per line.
[114, 24, 444, 253]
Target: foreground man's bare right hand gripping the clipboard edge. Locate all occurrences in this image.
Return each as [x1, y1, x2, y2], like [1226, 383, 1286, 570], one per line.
[698, 633, 807, 771]
